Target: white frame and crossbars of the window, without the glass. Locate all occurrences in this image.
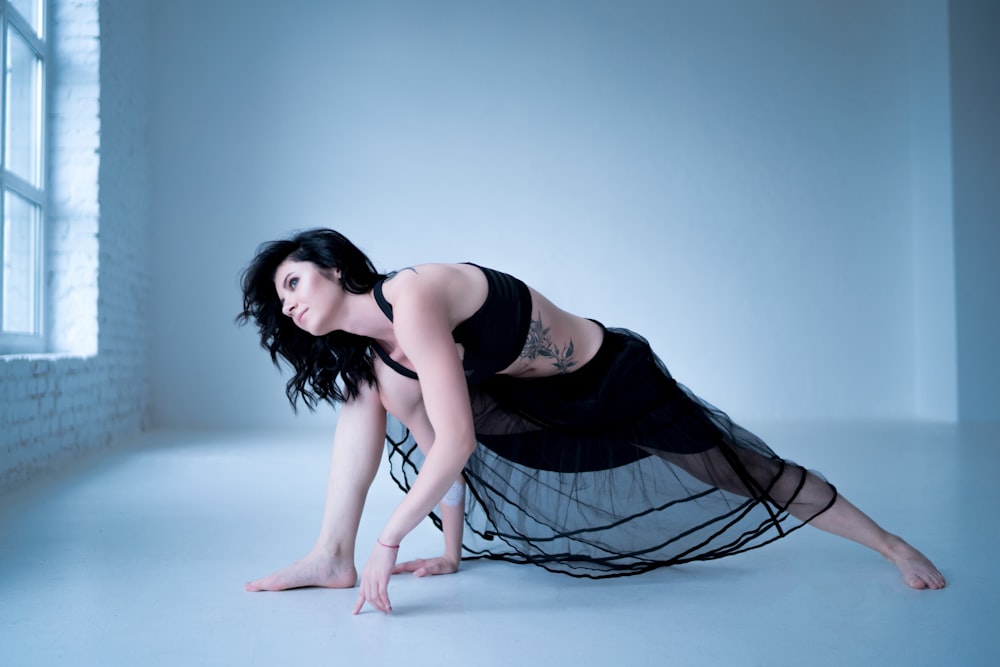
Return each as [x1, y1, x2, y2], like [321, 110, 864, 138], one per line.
[0, 0, 50, 355]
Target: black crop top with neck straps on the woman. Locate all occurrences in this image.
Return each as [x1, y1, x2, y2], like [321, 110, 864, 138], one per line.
[372, 262, 531, 384]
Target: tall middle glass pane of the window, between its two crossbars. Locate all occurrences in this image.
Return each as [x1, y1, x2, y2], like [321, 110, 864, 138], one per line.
[4, 24, 41, 186]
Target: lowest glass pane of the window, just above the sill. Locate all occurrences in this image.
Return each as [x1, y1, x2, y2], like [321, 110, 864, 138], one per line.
[3, 191, 41, 334]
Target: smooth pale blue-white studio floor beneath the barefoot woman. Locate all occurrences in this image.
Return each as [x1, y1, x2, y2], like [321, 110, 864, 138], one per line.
[0, 424, 1000, 667]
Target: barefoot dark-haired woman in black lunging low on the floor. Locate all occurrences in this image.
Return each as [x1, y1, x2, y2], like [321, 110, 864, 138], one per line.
[237, 229, 945, 613]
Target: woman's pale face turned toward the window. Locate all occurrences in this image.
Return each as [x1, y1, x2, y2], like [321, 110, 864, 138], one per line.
[274, 259, 344, 336]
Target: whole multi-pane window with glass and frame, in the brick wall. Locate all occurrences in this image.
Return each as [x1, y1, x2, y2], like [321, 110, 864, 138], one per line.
[0, 0, 47, 353]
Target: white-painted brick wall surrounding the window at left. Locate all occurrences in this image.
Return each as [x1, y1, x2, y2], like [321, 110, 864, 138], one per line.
[0, 0, 151, 492]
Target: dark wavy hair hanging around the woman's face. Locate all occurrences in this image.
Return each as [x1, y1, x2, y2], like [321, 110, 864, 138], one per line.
[236, 229, 386, 412]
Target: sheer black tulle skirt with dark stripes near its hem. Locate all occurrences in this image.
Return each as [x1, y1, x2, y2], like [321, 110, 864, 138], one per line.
[387, 329, 837, 578]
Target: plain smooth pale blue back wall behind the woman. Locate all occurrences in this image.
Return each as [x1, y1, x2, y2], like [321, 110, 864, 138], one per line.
[152, 0, 954, 428]
